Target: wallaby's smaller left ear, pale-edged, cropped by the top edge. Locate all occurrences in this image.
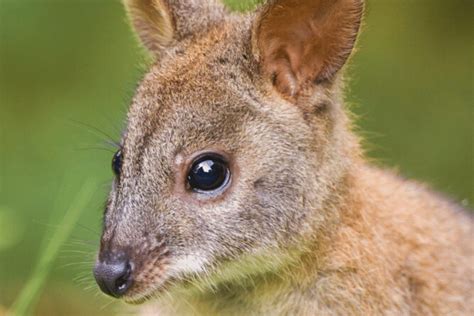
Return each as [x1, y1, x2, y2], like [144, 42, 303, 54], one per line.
[123, 0, 225, 53]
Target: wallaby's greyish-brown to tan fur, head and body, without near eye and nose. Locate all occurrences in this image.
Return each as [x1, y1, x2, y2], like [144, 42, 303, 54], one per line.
[94, 0, 474, 315]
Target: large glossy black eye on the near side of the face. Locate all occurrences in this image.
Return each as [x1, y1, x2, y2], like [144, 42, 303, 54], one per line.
[188, 155, 230, 192]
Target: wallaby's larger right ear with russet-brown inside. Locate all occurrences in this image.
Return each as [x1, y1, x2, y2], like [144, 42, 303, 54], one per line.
[253, 0, 363, 96]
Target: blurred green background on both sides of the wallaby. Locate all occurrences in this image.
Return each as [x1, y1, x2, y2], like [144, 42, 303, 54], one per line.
[0, 0, 474, 315]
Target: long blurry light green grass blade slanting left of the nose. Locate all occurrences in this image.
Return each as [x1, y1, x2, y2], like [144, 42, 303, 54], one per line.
[7, 181, 96, 316]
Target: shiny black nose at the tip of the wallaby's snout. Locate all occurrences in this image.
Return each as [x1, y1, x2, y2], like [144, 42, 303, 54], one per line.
[94, 259, 132, 297]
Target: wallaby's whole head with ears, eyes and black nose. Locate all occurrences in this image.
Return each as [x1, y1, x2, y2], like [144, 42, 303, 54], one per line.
[95, 0, 362, 302]
